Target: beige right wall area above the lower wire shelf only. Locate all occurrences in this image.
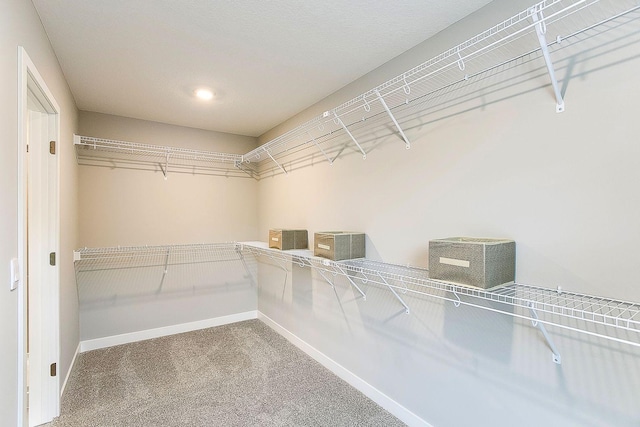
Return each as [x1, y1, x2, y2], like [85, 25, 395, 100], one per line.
[259, 1, 640, 300]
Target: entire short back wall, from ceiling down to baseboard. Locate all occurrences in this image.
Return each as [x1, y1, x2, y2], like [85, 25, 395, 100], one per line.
[78, 111, 258, 341]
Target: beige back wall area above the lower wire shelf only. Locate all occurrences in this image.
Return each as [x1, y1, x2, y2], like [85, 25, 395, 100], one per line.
[78, 111, 258, 247]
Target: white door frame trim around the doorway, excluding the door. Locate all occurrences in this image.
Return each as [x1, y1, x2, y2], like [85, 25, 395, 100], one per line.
[17, 46, 61, 426]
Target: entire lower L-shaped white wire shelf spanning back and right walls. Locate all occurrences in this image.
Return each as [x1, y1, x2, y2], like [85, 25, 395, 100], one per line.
[74, 242, 640, 363]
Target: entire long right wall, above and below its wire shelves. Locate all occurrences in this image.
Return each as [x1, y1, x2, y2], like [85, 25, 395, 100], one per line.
[258, 1, 640, 426]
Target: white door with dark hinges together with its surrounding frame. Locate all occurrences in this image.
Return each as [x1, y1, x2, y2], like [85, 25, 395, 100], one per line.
[18, 46, 60, 427]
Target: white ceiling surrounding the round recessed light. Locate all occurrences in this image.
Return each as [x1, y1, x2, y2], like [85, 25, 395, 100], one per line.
[33, 0, 489, 136]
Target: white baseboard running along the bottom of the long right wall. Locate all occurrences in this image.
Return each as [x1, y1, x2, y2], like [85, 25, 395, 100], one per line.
[258, 312, 432, 427]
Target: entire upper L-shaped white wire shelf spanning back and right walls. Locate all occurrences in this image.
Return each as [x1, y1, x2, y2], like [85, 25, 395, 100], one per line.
[74, 0, 640, 179]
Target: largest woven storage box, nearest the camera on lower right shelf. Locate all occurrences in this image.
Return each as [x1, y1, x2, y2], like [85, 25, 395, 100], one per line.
[429, 237, 516, 289]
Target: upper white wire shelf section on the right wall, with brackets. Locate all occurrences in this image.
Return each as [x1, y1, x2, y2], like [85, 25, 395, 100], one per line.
[243, 0, 640, 177]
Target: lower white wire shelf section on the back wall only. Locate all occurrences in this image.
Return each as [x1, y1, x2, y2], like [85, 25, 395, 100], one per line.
[73, 243, 242, 273]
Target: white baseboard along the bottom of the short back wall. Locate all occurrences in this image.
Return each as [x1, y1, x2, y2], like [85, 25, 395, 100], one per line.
[80, 310, 258, 353]
